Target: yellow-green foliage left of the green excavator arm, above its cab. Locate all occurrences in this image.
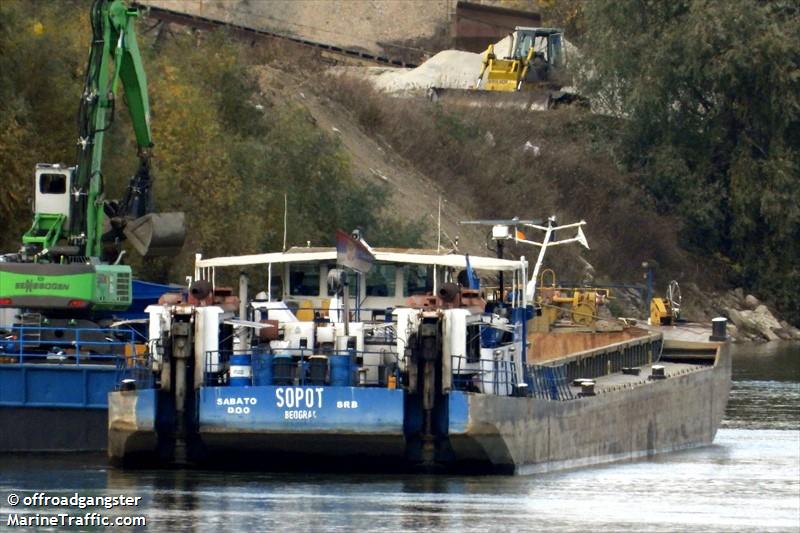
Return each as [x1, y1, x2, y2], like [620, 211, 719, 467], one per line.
[0, 2, 88, 250]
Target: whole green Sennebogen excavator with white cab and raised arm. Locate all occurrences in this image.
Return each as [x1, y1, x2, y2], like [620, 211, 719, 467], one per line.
[0, 0, 185, 325]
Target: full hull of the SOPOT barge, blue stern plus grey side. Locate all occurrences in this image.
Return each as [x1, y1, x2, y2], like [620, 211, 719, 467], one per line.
[109, 335, 731, 474]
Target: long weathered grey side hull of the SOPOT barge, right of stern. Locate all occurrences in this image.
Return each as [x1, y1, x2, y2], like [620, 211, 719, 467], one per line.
[450, 343, 731, 474]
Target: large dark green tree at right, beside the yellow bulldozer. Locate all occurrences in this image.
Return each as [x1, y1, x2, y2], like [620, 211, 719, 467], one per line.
[583, 0, 800, 320]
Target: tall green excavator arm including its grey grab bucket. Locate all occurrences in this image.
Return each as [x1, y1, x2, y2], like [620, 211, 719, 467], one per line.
[70, 0, 185, 257]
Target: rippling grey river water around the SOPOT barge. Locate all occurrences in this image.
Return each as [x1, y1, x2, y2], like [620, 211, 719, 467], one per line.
[0, 343, 800, 532]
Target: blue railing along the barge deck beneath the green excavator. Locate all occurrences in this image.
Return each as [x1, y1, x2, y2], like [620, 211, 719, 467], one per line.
[0, 324, 144, 365]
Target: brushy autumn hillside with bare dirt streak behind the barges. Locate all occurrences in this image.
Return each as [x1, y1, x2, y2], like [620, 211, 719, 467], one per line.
[0, 0, 798, 330]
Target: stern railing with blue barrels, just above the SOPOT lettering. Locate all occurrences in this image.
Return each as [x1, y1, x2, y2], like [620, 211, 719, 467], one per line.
[204, 347, 401, 387]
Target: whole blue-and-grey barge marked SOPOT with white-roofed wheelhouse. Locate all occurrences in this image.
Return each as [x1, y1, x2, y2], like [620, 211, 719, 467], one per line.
[108, 222, 730, 473]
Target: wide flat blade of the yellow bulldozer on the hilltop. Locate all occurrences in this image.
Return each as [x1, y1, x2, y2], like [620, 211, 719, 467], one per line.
[428, 87, 553, 111]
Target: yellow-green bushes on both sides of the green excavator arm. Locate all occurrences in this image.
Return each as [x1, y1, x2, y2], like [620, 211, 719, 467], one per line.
[0, 0, 421, 281]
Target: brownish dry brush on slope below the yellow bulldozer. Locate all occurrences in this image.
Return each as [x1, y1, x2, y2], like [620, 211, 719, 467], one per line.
[321, 76, 699, 282]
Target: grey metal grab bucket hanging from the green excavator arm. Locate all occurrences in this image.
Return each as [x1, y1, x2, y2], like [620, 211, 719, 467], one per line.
[123, 212, 186, 257]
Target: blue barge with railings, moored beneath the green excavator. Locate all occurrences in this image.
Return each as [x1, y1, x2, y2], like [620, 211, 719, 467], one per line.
[0, 280, 180, 453]
